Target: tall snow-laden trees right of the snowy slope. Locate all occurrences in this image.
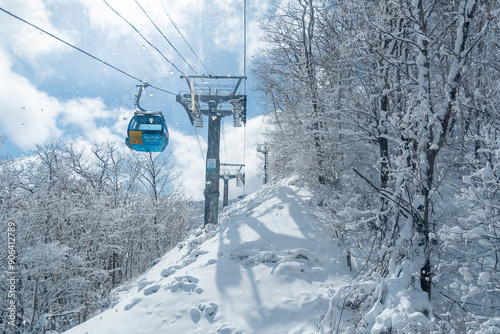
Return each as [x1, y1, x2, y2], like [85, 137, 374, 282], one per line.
[253, 0, 500, 333]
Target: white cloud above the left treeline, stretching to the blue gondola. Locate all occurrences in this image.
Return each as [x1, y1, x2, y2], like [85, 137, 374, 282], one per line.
[0, 49, 132, 149]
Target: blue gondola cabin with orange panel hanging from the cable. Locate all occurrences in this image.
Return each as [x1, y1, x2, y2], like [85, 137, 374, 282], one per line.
[126, 114, 168, 152]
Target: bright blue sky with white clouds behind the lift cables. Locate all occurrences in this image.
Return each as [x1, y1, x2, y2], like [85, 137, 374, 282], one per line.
[0, 0, 267, 199]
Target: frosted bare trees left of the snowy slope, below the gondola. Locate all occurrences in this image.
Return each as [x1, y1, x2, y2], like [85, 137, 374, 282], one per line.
[0, 142, 193, 333]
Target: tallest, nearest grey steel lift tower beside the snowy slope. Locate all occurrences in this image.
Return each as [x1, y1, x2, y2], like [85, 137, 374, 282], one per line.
[176, 75, 247, 226]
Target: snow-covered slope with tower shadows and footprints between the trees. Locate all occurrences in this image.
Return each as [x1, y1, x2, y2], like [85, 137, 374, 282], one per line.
[67, 181, 350, 334]
